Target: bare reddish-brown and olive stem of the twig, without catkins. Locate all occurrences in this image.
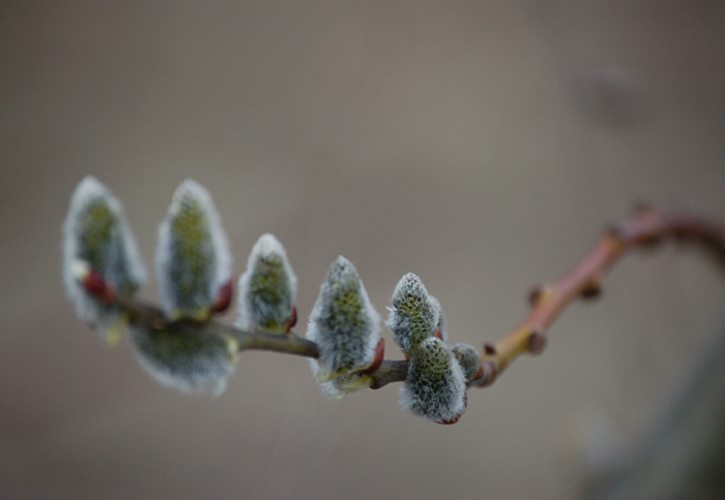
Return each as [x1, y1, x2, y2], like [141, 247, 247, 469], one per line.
[113, 207, 725, 389]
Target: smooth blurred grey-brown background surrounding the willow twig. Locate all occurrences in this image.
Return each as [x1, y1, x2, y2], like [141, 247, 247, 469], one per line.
[0, 0, 725, 499]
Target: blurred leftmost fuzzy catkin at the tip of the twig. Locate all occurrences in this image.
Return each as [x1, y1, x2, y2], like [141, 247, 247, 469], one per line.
[63, 176, 146, 342]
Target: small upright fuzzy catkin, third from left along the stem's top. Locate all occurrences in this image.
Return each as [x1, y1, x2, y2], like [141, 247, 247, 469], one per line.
[237, 233, 297, 333]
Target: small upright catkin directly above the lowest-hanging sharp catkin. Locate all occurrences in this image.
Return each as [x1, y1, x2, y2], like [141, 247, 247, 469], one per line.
[387, 273, 440, 355]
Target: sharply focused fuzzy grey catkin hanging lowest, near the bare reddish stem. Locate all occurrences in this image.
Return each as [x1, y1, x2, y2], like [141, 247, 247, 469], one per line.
[400, 337, 466, 423]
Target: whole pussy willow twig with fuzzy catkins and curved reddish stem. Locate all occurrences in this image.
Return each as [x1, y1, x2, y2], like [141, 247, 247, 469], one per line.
[63, 177, 725, 424]
